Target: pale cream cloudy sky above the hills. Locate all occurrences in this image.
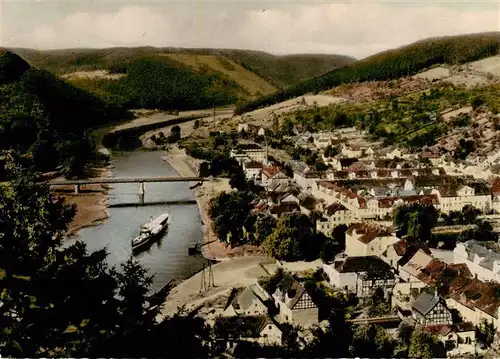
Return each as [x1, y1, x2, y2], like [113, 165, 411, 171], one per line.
[0, 0, 500, 59]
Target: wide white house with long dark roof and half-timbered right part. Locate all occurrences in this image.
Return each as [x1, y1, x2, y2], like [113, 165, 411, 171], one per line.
[323, 256, 396, 297]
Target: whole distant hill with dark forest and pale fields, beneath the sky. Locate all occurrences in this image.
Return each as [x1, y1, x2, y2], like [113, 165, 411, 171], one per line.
[13, 47, 355, 109]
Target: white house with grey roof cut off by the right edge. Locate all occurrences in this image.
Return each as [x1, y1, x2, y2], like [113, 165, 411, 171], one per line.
[453, 240, 500, 282]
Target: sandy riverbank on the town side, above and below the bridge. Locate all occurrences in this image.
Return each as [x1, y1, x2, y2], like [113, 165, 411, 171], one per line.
[163, 145, 259, 261]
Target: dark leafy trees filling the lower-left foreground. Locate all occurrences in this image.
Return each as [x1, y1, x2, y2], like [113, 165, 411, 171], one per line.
[0, 158, 210, 357]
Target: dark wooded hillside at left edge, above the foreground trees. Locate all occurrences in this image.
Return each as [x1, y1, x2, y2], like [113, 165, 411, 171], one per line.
[0, 51, 127, 174]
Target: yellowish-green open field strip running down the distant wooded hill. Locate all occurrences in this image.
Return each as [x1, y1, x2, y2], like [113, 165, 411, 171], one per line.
[162, 53, 276, 96]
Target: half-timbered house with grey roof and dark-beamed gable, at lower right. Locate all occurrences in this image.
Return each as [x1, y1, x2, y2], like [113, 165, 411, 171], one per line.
[411, 288, 453, 326]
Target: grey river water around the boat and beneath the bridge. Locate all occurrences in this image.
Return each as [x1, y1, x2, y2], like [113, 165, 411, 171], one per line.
[64, 151, 206, 292]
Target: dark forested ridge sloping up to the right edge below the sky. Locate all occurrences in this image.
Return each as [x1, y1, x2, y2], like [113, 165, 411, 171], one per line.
[237, 32, 500, 113]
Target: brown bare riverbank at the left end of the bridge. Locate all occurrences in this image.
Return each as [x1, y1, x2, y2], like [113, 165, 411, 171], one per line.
[52, 167, 111, 236]
